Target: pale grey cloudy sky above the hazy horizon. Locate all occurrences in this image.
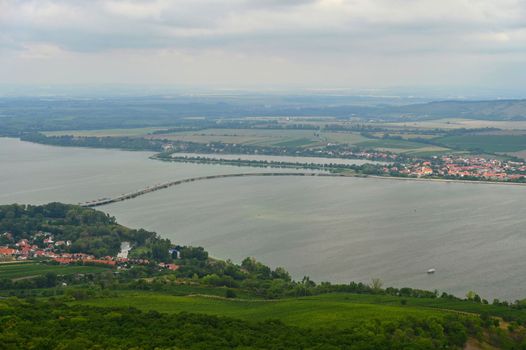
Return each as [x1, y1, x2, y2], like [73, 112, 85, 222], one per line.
[0, 0, 526, 93]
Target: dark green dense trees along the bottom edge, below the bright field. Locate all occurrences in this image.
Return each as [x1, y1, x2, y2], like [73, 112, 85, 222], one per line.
[0, 299, 483, 350]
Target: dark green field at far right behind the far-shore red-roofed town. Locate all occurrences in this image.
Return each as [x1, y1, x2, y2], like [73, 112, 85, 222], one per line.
[436, 135, 526, 153]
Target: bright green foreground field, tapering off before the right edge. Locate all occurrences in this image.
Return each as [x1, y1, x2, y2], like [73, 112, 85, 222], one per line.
[76, 291, 451, 328]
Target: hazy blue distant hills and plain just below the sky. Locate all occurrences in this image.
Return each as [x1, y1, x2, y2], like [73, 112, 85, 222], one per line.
[0, 96, 526, 135]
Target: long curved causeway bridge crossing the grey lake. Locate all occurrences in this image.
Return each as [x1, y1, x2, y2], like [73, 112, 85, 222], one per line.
[79, 172, 349, 208]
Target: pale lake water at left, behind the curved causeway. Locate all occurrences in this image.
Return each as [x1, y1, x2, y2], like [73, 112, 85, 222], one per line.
[0, 138, 310, 204]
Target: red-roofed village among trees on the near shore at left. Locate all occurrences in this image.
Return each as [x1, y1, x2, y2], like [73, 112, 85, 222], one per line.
[0, 231, 180, 271]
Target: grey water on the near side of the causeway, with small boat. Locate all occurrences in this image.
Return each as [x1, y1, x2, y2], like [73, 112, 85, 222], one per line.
[103, 177, 526, 300]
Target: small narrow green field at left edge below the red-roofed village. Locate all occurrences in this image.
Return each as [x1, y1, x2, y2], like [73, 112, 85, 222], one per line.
[0, 262, 108, 279]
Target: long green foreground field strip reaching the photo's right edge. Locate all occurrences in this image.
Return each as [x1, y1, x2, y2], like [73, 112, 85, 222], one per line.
[74, 287, 526, 328]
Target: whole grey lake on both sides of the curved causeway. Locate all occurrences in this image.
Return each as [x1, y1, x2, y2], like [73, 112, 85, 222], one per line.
[0, 139, 526, 300]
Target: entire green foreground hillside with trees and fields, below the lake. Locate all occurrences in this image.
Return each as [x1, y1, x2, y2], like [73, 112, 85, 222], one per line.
[0, 203, 526, 349]
